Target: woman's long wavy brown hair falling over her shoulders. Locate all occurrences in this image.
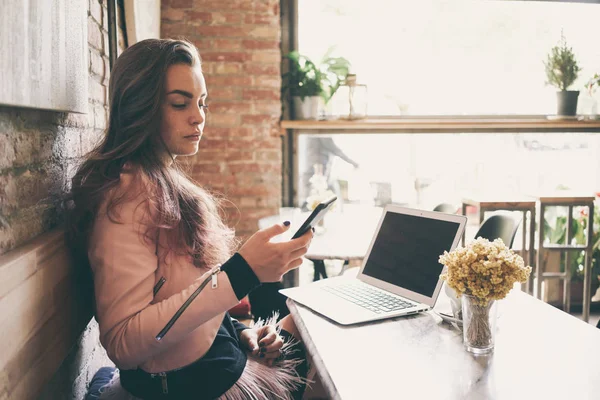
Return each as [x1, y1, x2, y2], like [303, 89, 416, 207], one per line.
[67, 39, 236, 267]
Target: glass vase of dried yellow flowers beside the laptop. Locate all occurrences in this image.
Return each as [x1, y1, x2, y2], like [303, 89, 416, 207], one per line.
[440, 237, 531, 354]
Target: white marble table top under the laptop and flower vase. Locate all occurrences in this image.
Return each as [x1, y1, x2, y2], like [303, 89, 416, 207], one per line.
[288, 290, 600, 400]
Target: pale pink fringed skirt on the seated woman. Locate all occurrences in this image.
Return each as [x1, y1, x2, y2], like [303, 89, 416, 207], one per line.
[100, 315, 308, 400]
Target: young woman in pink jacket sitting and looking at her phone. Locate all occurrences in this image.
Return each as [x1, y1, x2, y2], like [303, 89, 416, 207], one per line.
[68, 39, 312, 400]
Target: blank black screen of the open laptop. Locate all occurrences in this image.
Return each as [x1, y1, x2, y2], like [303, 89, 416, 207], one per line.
[363, 211, 460, 297]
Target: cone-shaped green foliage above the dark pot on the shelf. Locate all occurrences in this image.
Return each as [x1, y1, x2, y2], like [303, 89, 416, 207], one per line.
[544, 33, 581, 91]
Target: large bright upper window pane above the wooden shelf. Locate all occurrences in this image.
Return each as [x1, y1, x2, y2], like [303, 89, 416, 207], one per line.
[298, 0, 600, 115]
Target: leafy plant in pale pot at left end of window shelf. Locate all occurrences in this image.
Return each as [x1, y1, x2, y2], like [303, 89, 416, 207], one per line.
[282, 50, 350, 119]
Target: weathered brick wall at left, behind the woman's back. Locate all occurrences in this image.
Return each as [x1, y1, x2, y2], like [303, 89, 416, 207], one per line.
[0, 0, 123, 399]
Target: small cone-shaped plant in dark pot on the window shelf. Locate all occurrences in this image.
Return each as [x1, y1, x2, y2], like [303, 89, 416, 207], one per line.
[544, 34, 581, 116]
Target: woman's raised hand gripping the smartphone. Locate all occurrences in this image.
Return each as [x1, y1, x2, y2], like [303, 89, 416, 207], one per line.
[238, 224, 313, 283]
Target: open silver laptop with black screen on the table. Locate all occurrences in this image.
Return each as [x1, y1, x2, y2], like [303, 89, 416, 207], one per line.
[280, 205, 467, 325]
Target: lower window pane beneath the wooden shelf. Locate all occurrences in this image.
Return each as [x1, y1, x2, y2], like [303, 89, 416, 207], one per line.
[296, 133, 600, 209]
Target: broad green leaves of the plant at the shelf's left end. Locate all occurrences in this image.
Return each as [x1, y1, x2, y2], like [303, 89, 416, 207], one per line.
[282, 48, 350, 103]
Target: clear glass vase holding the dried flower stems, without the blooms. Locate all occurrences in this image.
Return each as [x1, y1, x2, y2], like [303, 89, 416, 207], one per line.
[461, 294, 497, 354]
